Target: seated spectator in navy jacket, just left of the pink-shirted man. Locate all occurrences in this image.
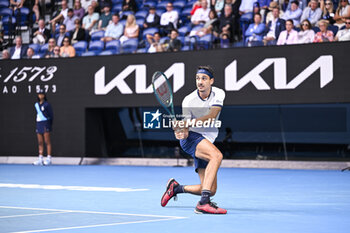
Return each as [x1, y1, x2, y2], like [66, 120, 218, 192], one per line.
[263, 7, 286, 45]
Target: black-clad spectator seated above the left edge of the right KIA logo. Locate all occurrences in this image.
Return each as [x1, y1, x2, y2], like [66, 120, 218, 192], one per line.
[219, 4, 235, 41]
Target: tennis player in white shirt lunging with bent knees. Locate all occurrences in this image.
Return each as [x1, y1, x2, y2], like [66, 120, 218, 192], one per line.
[161, 66, 227, 214]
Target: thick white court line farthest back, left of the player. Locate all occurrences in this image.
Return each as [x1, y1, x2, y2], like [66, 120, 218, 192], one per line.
[0, 183, 149, 192]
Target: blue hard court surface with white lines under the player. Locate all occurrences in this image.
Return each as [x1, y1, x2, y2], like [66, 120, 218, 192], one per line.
[0, 165, 350, 233]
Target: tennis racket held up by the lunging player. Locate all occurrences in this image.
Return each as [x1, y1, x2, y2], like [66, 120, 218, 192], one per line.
[152, 71, 176, 120]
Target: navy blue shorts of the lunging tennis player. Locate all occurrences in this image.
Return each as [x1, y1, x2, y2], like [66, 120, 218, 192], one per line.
[180, 131, 208, 172]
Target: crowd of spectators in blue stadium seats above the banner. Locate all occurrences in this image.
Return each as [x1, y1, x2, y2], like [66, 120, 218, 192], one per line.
[0, 0, 350, 59]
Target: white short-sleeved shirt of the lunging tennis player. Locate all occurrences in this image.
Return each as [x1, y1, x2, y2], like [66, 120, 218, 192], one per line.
[182, 87, 225, 143]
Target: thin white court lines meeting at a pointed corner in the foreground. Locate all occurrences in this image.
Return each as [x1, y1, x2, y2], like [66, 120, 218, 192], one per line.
[0, 206, 187, 233]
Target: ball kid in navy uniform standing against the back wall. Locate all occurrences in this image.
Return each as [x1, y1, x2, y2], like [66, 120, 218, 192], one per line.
[33, 89, 53, 165]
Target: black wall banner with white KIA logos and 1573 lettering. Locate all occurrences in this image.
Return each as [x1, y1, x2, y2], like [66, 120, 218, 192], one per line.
[0, 42, 350, 156]
